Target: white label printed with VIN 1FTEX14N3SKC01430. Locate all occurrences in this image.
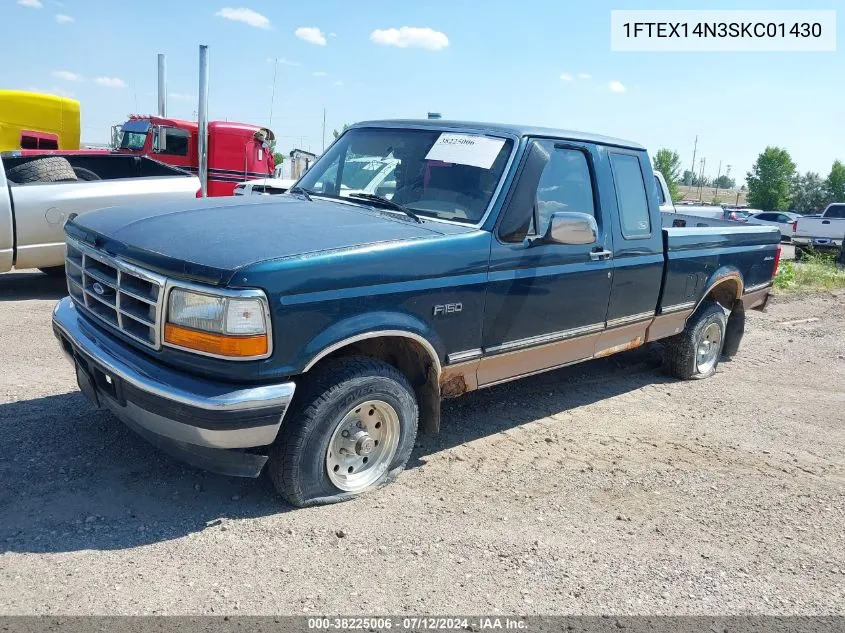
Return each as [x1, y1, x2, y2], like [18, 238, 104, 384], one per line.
[610, 10, 836, 52]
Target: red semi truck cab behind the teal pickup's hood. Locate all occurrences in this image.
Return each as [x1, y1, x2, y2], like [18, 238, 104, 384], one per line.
[117, 116, 274, 197]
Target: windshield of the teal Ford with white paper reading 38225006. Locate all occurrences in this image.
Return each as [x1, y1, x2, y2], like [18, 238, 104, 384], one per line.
[298, 128, 513, 224]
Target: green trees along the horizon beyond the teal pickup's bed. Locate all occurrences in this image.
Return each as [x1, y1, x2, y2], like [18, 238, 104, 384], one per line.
[653, 147, 845, 213]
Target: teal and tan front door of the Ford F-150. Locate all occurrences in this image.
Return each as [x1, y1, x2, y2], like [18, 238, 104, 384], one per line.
[478, 139, 613, 386]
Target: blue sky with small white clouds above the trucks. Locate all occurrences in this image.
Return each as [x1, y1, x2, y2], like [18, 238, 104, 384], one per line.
[0, 0, 845, 180]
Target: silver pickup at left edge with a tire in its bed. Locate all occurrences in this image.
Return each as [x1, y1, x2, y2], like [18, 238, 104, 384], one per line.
[0, 152, 200, 274]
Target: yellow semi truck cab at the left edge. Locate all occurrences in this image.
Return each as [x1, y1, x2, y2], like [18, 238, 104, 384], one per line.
[0, 90, 80, 152]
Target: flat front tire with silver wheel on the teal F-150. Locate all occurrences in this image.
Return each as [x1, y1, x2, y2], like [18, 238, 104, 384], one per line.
[267, 356, 419, 508]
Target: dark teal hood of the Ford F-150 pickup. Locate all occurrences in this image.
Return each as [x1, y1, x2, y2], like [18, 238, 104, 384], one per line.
[65, 195, 442, 284]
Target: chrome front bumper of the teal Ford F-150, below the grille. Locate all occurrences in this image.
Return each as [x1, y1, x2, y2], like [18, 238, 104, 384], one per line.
[53, 297, 296, 476]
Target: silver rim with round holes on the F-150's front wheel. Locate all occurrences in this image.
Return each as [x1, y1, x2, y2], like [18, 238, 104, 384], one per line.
[326, 400, 400, 492]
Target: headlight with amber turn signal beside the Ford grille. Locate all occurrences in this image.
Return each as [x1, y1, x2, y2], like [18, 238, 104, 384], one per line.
[164, 288, 270, 359]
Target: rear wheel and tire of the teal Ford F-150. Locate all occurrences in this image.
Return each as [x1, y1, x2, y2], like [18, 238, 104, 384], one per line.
[663, 301, 727, 380]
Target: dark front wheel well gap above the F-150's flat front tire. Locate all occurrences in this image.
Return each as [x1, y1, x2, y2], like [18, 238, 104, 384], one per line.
[312, 336, 440, 433]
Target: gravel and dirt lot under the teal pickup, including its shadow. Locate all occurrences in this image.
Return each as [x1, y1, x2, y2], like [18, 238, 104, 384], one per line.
[0, 273, 845, 614]
